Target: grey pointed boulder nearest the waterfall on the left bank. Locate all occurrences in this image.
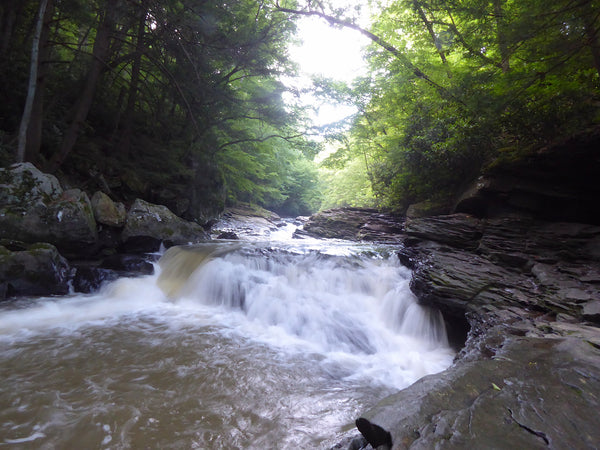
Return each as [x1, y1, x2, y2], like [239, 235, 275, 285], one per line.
[121, 199, 210, 252]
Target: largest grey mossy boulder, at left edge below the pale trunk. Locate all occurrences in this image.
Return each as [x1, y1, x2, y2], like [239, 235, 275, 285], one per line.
[0, 163, 98, 257]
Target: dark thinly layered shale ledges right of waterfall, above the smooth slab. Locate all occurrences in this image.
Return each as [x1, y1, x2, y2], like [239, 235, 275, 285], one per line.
[401, 215, 600, 319]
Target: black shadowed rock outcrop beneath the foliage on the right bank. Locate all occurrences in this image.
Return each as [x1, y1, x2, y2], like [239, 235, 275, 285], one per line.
[454, 127, 600, 225]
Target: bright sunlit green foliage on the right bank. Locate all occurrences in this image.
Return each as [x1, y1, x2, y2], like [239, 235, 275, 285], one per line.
[318, 0, 600, 210]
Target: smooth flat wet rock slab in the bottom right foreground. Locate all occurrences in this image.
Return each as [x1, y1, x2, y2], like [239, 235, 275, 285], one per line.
[358, 327, 600, 449]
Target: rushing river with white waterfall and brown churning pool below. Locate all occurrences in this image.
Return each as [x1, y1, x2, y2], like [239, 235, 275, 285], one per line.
[0, 223, 454, 449]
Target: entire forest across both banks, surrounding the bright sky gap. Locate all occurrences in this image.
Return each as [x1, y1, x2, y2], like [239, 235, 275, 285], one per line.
[0, 0, 600, 223]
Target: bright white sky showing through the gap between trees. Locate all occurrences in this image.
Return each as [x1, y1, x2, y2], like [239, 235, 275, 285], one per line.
[282, 4, 369, 130]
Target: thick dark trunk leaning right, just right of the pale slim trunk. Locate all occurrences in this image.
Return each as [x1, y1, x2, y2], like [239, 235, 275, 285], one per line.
[48, 0, 116, 172]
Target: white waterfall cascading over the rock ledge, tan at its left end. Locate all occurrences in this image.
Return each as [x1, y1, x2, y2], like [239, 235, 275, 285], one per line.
[158, 244, 448, 385]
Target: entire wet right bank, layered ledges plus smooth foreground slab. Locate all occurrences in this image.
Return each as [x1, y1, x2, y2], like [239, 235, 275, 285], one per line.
[309, 214, 600, 449]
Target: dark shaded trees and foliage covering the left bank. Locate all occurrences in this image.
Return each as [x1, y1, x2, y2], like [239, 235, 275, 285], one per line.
[0, 0, 319, 220]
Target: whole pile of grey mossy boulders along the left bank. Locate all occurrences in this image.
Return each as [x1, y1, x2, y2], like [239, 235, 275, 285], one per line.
[0, 163, 210, 300]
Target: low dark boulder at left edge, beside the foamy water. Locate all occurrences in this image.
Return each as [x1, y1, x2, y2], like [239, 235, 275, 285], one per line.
[0, 241, 72, 300]
